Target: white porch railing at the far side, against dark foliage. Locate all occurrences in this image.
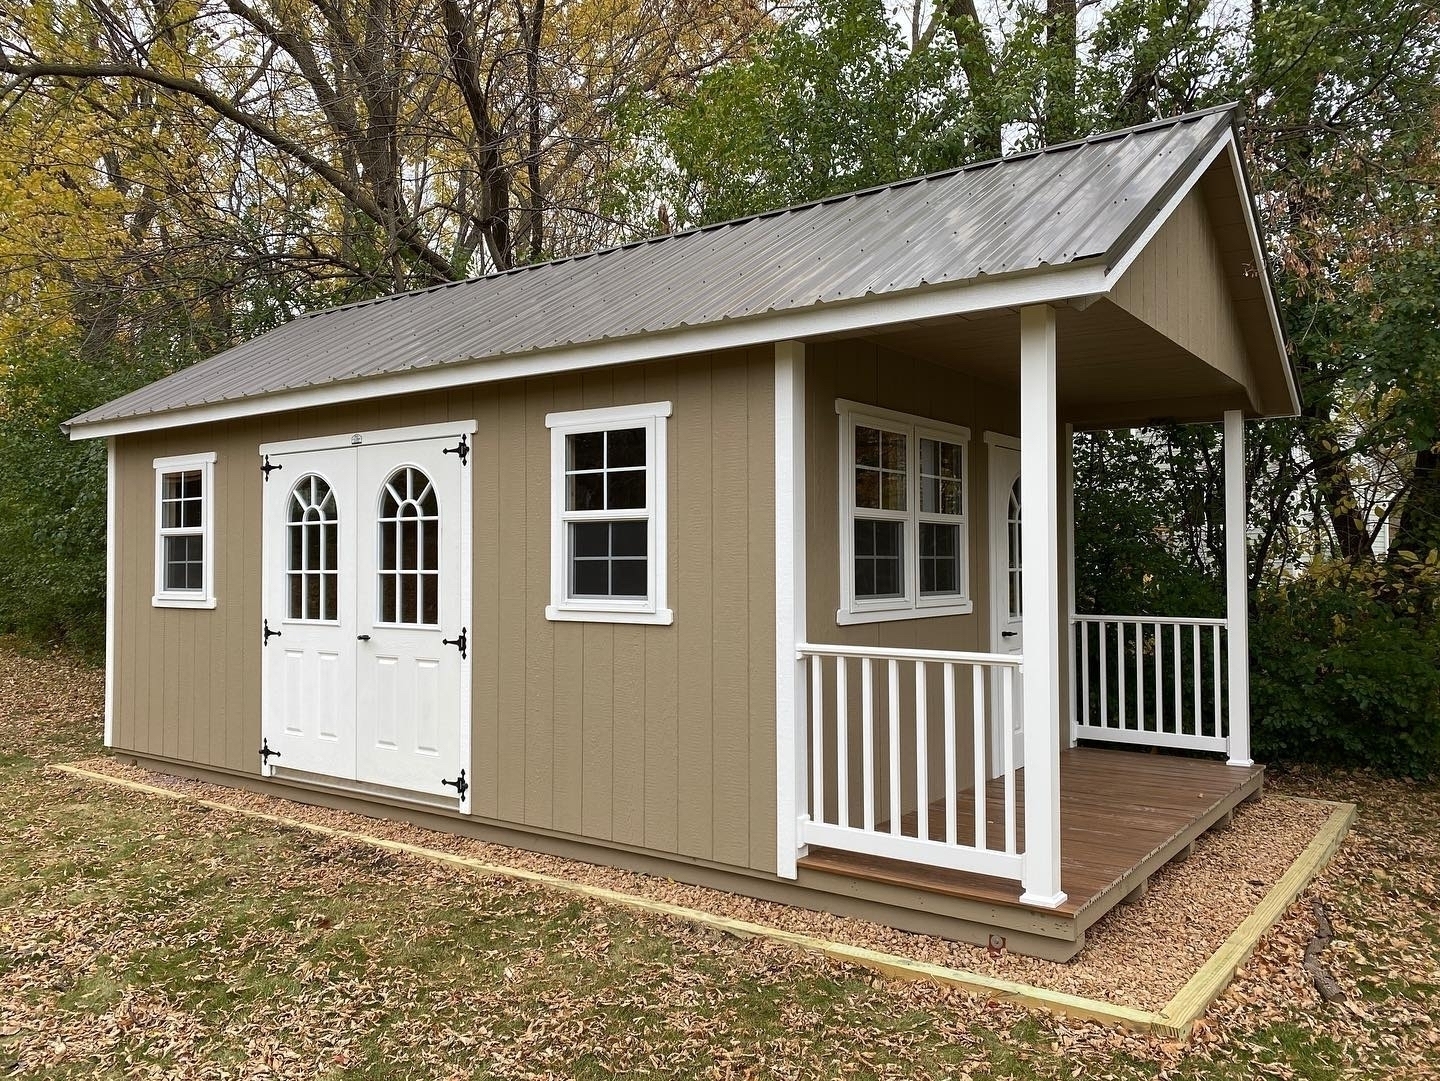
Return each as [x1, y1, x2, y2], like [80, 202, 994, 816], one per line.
[1073, 616, 1230, 751]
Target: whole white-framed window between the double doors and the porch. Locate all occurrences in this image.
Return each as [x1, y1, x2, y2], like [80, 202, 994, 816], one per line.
[546, 402, 672, 623]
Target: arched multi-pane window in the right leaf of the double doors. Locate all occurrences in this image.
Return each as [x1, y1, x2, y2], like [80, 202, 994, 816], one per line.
[376, 465, 441, 626]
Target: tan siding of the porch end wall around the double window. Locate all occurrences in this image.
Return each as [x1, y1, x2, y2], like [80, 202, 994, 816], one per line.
[805, 342, 1020, 820]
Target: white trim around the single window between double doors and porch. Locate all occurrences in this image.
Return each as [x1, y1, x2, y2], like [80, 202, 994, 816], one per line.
[544, 402, 675, 626]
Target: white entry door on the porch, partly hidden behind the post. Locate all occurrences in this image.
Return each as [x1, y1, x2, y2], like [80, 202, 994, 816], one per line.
[986, 443, 1025, 776]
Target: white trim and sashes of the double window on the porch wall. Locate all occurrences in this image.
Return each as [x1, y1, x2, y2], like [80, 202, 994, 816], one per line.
[835, 399, 975, 626]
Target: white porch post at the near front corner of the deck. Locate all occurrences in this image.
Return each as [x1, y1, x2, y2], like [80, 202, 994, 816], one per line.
[1020, 305, 1068, 908]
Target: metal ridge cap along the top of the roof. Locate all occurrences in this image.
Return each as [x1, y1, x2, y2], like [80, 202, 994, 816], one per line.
[298, 101, 1240, 318]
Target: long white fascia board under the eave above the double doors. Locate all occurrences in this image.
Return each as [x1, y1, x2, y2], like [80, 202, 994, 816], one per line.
[69, 261, 1109, 439]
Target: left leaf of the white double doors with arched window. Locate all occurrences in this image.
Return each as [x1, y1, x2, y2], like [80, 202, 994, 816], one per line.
[262, 449, 357, 779]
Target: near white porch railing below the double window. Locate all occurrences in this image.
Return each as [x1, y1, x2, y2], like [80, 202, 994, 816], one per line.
[796, 643, 1024, 881]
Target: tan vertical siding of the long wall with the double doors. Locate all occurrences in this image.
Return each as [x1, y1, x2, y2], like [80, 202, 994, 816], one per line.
[114, 347, 775, 871]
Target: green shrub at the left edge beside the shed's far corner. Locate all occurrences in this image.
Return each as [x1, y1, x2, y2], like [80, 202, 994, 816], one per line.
[0, 348, 164, 656]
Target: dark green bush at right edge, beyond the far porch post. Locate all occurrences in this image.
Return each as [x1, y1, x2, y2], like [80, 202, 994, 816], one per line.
[1250, 553, 1440, 777]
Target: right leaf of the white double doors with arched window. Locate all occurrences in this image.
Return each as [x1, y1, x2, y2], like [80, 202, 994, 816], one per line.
[356, 439, 469, 796]
